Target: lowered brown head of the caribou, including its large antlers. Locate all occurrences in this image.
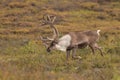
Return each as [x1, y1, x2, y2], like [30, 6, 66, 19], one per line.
[40, 15, 59, 52]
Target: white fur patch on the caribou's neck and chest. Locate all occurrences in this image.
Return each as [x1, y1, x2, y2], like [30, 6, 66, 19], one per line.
[55, 34, 71, 52]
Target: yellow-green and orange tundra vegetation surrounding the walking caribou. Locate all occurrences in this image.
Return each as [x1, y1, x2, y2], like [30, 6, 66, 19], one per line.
[0, 0, 120, 80]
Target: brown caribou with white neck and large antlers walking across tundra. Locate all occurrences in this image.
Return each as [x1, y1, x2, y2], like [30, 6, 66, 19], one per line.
[40, 15, 103, 59]
